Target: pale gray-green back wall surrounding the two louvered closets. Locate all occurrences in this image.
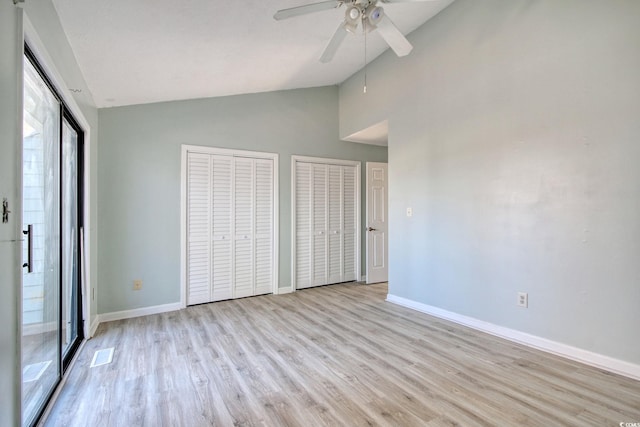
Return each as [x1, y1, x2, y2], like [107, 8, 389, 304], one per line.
[98, 87, 387, 313]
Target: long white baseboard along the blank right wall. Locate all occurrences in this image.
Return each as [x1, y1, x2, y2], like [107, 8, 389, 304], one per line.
[387, 294, 640, 380]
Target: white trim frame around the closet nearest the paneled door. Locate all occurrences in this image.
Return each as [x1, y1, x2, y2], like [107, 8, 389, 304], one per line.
[291, 155, 362, 292]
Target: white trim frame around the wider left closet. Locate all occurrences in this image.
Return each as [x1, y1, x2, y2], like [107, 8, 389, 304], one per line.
[180, 144, 280, 308]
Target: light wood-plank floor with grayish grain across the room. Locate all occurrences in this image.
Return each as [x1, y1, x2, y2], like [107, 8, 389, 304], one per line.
[46, 284, 640, 427]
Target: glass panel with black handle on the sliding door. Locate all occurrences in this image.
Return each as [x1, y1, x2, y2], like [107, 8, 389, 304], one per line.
[22, 56, 61, 425]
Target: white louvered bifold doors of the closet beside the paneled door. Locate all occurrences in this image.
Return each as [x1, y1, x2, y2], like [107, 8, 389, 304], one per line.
[294, 162, 358, 289]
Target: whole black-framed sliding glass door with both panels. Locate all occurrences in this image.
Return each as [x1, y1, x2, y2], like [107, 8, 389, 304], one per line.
[22, 47, 82, 425]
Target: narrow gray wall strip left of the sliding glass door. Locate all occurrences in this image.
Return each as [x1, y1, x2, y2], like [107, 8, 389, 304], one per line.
[0, 0, 22, 426]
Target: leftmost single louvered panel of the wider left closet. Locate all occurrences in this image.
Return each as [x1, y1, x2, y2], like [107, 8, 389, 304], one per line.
[187, 153, 211, 304]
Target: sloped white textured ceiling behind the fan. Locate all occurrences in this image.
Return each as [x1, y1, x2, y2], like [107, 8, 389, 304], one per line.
[53, 0, 453, 107]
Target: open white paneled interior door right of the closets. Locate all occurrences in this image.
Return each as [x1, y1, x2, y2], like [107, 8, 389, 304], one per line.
[366, 162, 389, 283]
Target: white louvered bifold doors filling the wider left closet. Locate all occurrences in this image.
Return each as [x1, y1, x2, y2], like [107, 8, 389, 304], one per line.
[187, 152, 274, 305]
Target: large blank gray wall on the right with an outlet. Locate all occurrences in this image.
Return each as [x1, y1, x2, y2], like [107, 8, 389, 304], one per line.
[340, 0, 640, 364]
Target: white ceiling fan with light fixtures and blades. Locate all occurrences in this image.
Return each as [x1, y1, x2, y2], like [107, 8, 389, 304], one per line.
[273, 0, 434, 63]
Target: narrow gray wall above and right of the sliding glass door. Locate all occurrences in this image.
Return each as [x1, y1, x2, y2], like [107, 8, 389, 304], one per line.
[25, 0, 98, 330]
